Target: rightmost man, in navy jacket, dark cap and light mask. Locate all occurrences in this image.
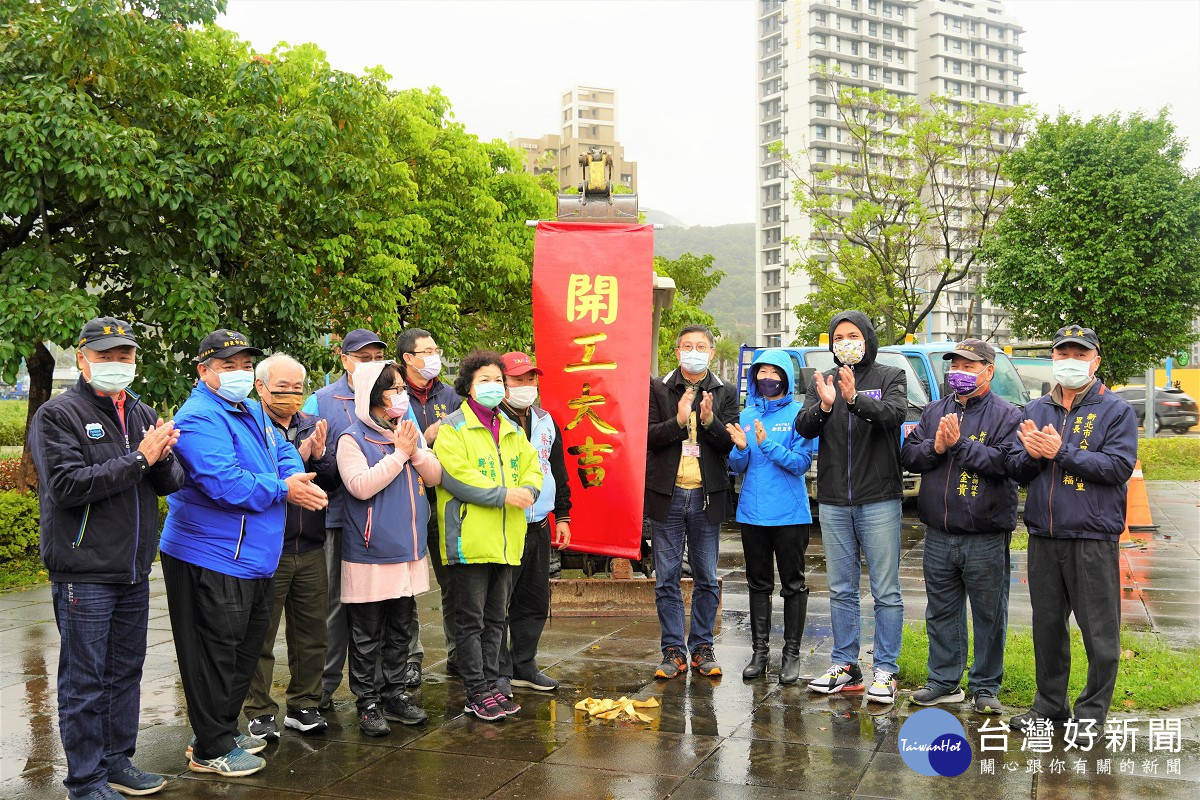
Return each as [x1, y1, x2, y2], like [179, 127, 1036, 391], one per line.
[1008, 325, 1138, 730]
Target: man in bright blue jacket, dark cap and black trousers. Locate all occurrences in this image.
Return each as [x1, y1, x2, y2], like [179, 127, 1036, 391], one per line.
[160, 330, 326, 777]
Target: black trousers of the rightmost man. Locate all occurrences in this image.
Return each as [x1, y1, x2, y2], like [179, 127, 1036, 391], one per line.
[1027, 536, 1121, 727]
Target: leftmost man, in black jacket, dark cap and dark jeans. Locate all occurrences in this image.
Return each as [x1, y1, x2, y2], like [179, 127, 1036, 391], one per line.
[29, 317, 184, 800]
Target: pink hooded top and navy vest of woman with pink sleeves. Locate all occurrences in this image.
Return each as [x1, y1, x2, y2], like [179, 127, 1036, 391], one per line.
[338, 361, 433, 564]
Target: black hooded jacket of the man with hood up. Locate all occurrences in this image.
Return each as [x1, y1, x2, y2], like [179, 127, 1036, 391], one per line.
[796, 311, 908, 506]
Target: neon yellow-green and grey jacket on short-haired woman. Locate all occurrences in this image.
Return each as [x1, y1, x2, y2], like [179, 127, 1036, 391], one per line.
[433, 403, 542, 566]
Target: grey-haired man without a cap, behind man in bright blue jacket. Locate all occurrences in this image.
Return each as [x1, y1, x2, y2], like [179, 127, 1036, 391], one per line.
[242, 353, 341, 739]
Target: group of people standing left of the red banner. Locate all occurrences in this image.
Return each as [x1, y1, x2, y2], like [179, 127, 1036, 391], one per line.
[30, 318, 571, 800]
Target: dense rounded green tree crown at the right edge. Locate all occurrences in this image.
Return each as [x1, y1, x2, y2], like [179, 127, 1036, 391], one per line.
[980, 110, 1200, 383]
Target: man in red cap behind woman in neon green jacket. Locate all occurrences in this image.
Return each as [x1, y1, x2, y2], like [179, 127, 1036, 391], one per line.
[496, 353, 571, 698]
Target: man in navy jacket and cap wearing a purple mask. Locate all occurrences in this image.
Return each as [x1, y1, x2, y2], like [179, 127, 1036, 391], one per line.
[900, 339, 1021, 714]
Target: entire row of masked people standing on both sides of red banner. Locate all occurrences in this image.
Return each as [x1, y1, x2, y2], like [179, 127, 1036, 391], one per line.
[30, 311, 1138, 800]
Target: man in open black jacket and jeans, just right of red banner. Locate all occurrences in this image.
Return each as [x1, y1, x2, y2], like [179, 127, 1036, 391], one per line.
[646, 325, 738, 678]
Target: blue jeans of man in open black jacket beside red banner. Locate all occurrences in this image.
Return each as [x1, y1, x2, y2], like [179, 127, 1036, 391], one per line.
[650, 487, 721, 650]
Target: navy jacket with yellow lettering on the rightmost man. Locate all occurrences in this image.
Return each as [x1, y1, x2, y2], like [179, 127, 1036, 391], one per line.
[1008, 380, 1138, 541]
